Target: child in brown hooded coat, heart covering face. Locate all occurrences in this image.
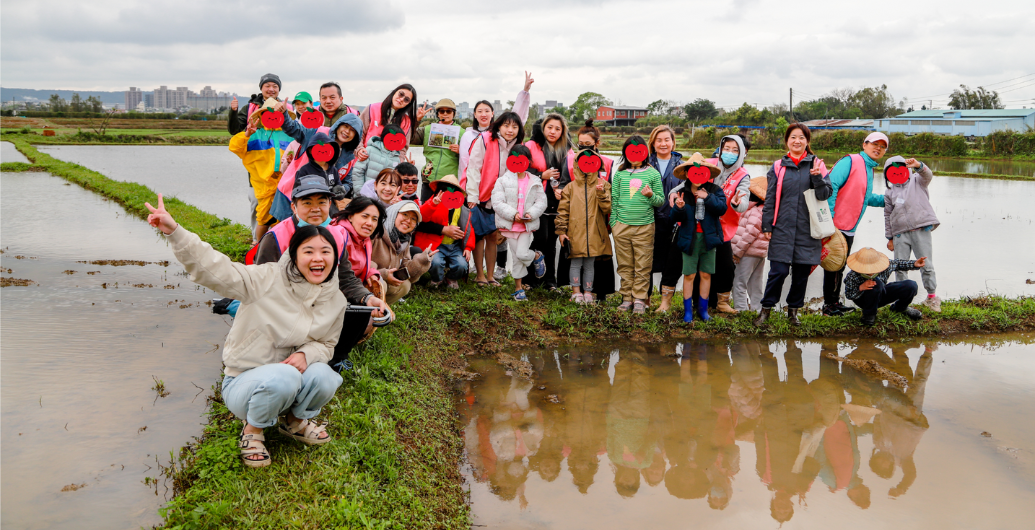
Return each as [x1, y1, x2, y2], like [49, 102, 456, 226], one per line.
[555, 149, 611, 303]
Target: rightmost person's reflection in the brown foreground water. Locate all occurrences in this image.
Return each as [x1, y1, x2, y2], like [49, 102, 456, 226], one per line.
[853, 344, 937, 497]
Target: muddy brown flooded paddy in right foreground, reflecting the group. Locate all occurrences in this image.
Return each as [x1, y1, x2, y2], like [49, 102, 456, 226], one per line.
[457, 334, 1035, 529]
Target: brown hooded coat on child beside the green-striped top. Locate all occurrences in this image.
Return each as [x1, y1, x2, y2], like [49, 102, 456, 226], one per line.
[554, 166, 612, 258]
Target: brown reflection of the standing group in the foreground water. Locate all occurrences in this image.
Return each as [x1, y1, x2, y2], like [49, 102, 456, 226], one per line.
[460, 341, 1035, 527]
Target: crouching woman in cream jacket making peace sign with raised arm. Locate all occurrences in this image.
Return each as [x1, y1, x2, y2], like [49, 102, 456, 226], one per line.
[147, 195, 347, 468]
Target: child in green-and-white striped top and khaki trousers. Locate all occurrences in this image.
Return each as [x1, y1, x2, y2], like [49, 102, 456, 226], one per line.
[608, 136, 664, 313]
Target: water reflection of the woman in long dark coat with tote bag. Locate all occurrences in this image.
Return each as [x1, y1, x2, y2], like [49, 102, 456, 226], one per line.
[755, 341, 819, 523]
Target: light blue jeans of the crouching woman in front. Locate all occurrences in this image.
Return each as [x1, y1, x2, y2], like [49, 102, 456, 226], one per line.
[223, 362, 342, 429]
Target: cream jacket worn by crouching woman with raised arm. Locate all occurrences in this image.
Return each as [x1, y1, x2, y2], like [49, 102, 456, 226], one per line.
[168, 227, 347, 377]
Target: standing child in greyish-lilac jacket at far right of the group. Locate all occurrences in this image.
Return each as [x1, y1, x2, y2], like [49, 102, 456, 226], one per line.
[884, 156, 942, 313]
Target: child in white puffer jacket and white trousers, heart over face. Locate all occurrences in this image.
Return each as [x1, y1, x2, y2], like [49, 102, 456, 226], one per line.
[492, 144, 546, 301]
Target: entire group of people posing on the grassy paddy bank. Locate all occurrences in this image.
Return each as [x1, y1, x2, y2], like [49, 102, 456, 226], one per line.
[148, 72, 938, 467]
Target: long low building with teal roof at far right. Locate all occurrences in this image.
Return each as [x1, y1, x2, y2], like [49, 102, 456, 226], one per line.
[876, 109, 1035, 137]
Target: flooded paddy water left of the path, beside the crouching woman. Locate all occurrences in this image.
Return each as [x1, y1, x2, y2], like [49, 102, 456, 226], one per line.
[0, 173, 229, 529]
